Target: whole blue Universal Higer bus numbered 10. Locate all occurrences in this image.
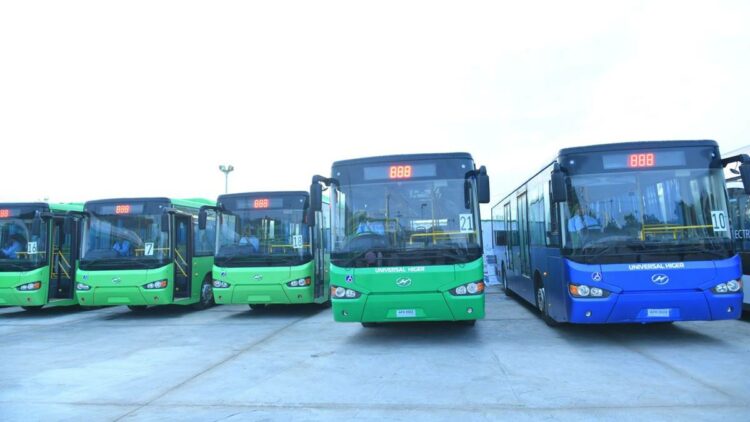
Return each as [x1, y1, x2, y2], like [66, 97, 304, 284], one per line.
[492, 141, 750, 325]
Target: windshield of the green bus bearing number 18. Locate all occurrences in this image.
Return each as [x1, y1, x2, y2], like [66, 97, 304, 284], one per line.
[215, 208, 312, 267]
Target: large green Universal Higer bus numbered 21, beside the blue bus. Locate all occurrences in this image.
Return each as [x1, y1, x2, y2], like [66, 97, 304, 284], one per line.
[310, 153, 490, 326]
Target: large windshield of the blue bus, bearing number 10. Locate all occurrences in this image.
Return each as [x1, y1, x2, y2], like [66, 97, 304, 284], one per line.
[562, 169, 732, 263]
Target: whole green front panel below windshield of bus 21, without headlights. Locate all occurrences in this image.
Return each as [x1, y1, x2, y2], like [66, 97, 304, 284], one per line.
[331, 259, 484, 322]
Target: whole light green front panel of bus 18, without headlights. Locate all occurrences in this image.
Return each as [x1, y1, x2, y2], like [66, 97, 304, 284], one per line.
[213, 261, 326, 305]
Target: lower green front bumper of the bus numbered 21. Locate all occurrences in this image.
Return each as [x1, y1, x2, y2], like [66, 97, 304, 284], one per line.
[331, 292, 484, 322]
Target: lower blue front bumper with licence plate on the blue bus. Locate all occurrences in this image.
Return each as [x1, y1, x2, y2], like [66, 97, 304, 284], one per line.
[568, 291, 742, 324]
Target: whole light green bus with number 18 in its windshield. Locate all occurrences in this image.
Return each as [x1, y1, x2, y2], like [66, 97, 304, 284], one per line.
[200, 191, 330, 309]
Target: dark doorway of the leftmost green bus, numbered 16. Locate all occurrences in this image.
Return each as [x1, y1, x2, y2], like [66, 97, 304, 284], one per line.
[47, 217, 78, 301]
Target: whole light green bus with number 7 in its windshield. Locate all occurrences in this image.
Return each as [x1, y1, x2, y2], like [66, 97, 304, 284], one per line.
[76, 198, 216, 311]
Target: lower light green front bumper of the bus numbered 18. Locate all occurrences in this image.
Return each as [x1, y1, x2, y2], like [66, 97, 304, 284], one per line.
[214, 284, 315, 305]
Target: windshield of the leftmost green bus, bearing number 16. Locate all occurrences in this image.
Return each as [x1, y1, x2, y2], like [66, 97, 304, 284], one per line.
[0, 212, 47, 271]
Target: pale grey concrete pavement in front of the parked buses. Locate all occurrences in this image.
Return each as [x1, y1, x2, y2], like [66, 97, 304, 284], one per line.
[0, 287, 750, 421]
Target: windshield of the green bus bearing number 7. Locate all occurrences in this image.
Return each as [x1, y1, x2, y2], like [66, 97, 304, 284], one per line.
[80, 213, 170, 269]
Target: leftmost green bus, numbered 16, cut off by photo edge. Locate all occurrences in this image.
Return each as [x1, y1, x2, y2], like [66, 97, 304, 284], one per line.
[0, 202, 83, 311]
